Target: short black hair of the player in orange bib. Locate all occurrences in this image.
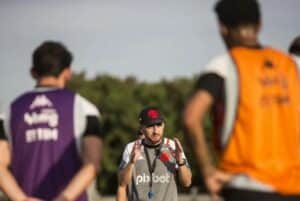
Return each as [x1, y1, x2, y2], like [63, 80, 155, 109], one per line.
[215, 0, 261, 27]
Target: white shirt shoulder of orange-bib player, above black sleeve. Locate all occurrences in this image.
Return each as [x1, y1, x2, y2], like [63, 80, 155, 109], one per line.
[201, 53, 232, 77]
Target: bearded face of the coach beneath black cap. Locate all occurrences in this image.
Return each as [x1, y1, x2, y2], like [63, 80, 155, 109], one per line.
[142, 123, 165, 145]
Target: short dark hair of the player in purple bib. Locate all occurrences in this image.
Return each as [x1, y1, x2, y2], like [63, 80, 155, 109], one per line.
[32, 41, 72, 77]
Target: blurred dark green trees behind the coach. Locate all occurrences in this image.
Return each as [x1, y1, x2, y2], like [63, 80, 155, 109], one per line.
[68, 73, 211, 194]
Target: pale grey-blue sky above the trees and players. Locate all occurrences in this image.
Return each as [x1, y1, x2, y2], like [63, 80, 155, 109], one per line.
[0, 0, 300, 108]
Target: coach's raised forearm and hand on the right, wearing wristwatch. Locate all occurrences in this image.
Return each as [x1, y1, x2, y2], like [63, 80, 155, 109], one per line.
[174, 138, 192, 187]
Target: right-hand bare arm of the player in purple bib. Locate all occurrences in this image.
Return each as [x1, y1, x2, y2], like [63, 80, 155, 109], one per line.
[55, 135, 102, 201]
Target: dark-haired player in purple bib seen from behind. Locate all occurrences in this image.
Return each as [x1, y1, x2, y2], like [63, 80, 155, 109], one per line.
[0, 41, 102, 201]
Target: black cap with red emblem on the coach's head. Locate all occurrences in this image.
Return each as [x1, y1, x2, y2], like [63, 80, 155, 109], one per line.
[139, 107, 164, 126]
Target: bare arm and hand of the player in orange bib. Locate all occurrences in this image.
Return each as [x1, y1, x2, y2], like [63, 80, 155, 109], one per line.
[184, 90, 230, 200]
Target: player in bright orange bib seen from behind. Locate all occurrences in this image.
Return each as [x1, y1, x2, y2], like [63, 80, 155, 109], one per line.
[184, 0, 300, 201]
